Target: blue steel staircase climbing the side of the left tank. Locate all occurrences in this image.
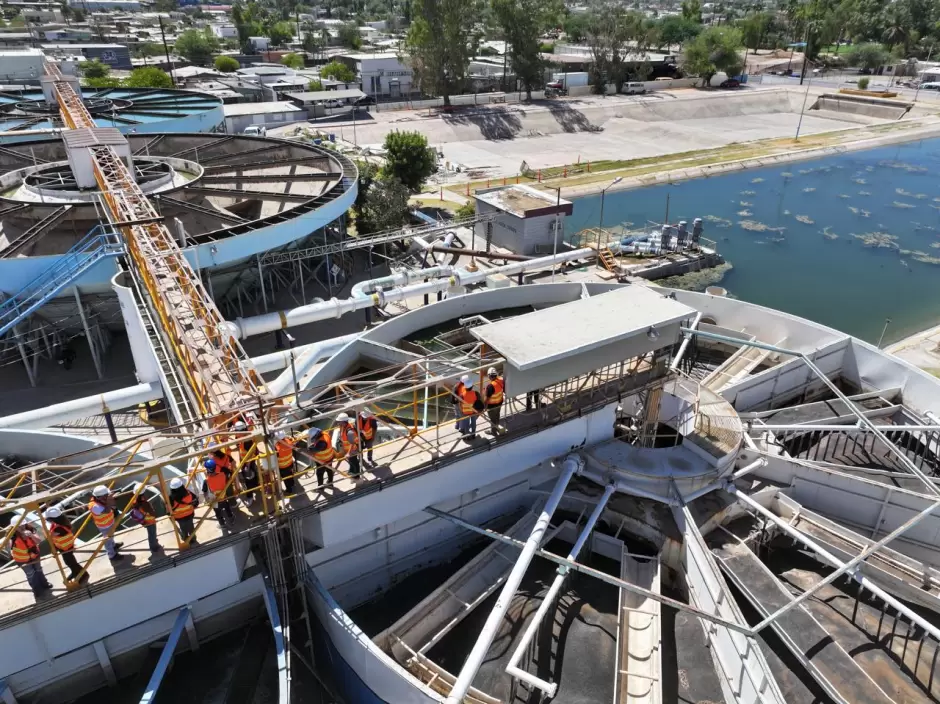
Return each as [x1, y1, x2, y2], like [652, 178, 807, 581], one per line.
[0, 225, 124, 335]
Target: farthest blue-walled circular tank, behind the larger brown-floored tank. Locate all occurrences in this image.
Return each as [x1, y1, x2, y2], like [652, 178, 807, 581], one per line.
[0, 88, 224, 144]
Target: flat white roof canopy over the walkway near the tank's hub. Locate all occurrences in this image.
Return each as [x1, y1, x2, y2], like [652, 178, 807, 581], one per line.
[470, 284, 696, 395]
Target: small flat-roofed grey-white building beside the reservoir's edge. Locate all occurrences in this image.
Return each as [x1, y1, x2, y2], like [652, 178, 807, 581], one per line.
[474, 185, 574, 255]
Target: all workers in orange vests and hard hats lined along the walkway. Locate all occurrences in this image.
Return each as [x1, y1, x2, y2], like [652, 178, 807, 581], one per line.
[10, 367, 505, 597]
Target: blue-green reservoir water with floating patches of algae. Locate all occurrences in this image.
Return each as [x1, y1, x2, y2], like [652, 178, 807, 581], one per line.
[565, 139, 940, 342]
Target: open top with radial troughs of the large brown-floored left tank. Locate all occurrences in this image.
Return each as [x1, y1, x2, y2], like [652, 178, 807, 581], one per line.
[0, 134, 356, 258]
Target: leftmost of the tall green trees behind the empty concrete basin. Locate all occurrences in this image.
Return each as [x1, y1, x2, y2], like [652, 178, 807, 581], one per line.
[405, 0, 482, 106]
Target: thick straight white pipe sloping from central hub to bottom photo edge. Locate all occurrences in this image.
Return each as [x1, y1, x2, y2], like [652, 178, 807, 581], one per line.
[445, 455, 584, 704]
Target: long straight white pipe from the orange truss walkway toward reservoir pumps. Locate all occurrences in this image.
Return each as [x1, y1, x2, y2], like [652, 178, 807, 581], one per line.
[226, 249, 596, 339]
